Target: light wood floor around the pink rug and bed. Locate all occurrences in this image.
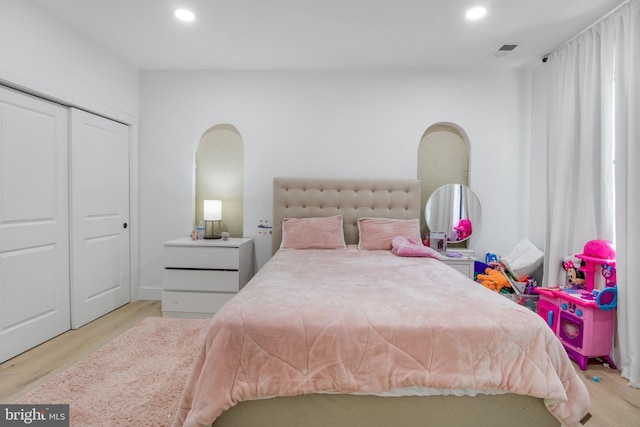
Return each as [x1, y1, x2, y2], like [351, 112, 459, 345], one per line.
[0, 301, 640, 427]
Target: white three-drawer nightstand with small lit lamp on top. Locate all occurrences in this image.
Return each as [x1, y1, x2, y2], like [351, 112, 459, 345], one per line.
[162, 237, 253, 318]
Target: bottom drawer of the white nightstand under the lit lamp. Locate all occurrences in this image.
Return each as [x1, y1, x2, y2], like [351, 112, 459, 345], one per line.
[162, 291, 235, 317]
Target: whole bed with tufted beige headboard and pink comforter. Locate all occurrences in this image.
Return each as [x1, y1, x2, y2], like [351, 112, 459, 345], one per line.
[174, 178, 589, 427]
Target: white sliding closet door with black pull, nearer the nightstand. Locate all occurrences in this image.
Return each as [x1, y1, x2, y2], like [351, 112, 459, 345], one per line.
[71, 108, 131, 329]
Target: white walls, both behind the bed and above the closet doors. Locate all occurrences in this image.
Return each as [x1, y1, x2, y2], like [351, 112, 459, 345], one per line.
[0, 0, 535, 298]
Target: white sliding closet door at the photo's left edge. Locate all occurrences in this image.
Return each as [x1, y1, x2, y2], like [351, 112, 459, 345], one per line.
[0, 87, 70, 362]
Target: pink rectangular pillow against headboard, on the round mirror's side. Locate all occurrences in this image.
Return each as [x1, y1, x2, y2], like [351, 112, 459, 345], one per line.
[358, 218, 422, 250]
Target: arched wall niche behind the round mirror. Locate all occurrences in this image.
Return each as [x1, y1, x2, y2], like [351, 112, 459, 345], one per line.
[418, 122, 470, 234]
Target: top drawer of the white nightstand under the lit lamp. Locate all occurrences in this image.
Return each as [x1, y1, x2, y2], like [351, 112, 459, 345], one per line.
[163, 245, 240, 270]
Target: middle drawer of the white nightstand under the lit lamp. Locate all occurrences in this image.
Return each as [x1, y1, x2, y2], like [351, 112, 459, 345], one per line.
[162, 269, 241, 292]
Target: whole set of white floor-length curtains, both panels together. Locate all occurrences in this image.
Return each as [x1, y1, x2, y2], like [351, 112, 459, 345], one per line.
[543, 0, 640, 387]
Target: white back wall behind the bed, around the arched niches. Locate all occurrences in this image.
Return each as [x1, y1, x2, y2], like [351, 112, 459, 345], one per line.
[140, 71, 529, 295]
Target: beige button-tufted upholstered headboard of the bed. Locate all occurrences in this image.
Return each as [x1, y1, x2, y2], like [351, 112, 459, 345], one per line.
[271, 178, 421, 253]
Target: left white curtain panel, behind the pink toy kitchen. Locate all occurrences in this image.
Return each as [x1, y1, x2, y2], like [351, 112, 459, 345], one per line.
[543, 19, 614, 286]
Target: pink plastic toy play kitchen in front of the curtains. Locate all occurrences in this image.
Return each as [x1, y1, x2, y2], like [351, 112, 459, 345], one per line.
[538, 240, 617, 370]
